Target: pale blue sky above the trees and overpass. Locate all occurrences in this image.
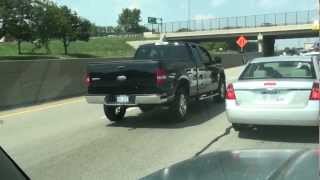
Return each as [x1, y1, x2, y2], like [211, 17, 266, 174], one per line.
[53, 0, 318, 48]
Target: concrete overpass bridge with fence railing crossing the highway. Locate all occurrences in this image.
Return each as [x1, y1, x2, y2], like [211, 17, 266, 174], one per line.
[149, 10, 319, 56]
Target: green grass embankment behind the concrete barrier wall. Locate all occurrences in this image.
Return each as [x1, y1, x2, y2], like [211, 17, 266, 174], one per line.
[0, 37, 141, 60]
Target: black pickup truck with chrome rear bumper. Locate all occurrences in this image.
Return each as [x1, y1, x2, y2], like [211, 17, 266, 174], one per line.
[85, 42, 226, 121]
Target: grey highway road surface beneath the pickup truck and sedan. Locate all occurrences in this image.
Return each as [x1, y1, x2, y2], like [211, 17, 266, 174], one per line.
[0, 68, 319, 180]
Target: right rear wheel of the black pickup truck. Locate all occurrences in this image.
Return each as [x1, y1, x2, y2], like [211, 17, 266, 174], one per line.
[170, 88, 189, 122]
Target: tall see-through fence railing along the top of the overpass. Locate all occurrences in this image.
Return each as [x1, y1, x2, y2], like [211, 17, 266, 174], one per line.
[145, 10, 318, 32]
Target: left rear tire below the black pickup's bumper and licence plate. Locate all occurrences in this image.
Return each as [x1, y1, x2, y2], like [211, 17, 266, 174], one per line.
[103, 105, 127, 122]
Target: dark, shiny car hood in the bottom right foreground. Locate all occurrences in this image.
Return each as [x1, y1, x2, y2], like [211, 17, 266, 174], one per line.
[142, 150, 319, 180]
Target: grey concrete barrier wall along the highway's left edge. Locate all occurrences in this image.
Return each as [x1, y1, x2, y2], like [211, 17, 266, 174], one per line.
[0, 54, 257, 109]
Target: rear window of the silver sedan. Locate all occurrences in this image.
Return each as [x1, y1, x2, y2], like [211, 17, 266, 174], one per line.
[240, 61, 316, 80]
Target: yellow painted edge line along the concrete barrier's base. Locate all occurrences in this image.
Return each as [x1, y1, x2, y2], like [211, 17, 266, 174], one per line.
[0, 99, 84, 119]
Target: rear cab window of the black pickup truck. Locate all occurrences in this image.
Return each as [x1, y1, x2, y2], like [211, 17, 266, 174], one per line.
[135, 45, 190, 61]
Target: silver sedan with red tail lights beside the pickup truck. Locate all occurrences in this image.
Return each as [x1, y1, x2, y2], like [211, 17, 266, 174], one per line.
[226, 56, 320, 130]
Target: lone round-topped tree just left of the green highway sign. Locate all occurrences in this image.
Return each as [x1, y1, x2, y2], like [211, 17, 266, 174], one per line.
[118, 8, 142, 33]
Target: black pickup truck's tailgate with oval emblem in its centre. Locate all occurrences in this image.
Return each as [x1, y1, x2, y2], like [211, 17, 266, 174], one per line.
[88, 60, 159, 95]
